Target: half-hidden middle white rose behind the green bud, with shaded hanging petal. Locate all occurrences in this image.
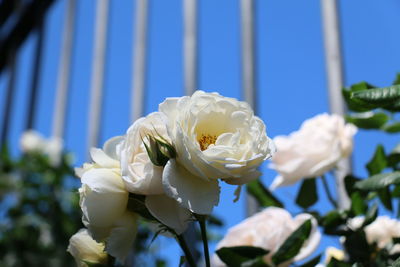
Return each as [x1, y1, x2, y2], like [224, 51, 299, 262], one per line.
[118, 112, 191, 234]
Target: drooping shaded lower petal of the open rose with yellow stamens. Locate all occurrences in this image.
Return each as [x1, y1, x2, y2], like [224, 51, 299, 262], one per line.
[163, 159, 220, 214]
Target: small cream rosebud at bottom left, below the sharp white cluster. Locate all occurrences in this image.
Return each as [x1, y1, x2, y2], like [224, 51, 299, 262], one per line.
[67, 229, 108, 267]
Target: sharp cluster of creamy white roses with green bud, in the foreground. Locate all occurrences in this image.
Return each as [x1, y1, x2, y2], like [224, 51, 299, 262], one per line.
[68, 91, 274, 261]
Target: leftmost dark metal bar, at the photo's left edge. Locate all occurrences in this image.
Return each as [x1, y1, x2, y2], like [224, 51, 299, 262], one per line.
[0, 50, 17, 149]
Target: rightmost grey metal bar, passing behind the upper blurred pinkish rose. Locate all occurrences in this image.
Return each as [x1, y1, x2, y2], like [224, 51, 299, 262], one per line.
[321, 0, 351, 209]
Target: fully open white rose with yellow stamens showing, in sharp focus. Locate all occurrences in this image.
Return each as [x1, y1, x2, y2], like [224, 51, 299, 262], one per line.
[159, 91, 274, 214]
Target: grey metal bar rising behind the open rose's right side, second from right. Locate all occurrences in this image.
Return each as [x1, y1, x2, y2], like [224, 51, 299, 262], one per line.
[240, 0, 259, 216]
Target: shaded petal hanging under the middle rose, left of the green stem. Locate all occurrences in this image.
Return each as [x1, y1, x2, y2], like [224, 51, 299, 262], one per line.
[145, 195, 191, 234]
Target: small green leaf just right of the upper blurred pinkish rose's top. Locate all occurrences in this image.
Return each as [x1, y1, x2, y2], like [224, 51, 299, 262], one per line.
[346, 112, 389, 129]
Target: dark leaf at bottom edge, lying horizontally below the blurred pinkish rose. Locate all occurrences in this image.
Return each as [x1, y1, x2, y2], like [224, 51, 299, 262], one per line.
[216, 246, 268, 267]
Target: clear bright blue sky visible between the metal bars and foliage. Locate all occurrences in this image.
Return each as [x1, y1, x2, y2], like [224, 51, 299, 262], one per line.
[0, 0, 400, 266]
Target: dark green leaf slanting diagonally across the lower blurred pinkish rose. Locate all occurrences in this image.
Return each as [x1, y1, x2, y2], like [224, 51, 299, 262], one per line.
[272, 220, 312, 264]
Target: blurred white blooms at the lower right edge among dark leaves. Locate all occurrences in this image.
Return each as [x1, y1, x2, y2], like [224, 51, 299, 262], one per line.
[348, 216, 400, 254]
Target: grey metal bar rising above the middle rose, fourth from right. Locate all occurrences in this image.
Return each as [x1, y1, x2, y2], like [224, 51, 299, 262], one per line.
[131, 0, 148, 122]
